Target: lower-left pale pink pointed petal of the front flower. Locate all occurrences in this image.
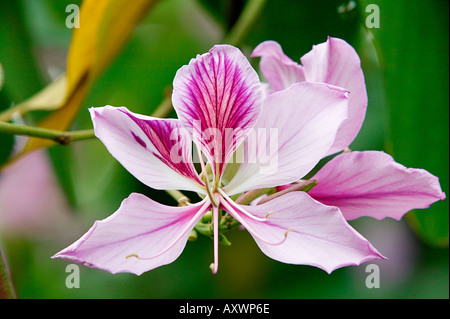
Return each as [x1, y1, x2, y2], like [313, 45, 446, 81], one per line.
[52, 193, 210, 275]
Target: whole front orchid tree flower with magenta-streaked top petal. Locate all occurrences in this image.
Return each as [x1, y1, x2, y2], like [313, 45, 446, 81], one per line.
[53, 45, 384, 275]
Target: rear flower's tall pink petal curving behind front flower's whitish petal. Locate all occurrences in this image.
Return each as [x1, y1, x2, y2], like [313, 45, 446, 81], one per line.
[300, 37, 367, 154]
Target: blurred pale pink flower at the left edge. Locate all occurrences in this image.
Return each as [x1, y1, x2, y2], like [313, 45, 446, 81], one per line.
[0, 150, 75, 237]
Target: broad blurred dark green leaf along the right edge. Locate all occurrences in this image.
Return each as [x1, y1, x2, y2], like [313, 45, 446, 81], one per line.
[361, 0, 449, 245]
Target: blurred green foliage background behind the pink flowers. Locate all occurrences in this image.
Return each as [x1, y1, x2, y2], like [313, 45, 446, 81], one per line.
[0, 0, 449, 298]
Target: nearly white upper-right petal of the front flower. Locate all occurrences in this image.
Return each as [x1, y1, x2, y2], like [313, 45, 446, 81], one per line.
[225, 82, 348, 195]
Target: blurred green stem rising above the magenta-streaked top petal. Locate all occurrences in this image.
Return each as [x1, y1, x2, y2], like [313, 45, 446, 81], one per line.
[224, 0, 267, 46]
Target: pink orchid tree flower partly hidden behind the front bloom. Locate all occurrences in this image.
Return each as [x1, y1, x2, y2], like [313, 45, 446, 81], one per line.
[251, 37, 445, 220]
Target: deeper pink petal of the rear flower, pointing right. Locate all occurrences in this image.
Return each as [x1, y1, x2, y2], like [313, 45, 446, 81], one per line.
[309, 151, 445, 220]
